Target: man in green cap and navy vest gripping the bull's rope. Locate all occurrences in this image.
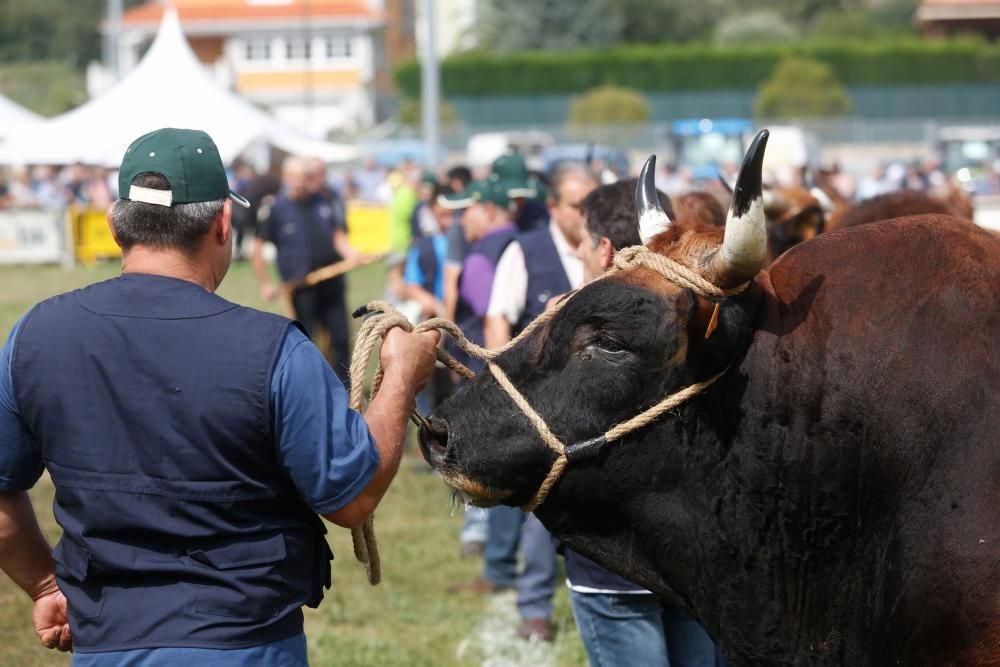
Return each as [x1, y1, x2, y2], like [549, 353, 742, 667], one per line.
[0, 128, 438, 667]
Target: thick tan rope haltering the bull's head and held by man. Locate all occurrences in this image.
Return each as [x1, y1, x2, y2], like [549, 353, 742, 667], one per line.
[350, 246, 744, 586]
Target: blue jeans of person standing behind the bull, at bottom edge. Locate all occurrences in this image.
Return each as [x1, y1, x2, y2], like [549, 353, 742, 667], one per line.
[570, 590, 726, 667]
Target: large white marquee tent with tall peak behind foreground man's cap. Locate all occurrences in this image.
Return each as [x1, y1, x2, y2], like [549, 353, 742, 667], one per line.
[0, 8, 357, 167]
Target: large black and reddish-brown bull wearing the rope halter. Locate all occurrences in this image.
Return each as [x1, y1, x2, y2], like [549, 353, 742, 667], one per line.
[421, 130, 1000, 667]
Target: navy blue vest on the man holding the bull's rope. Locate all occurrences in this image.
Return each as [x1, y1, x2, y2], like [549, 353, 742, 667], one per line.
[12, 274, 332, 652]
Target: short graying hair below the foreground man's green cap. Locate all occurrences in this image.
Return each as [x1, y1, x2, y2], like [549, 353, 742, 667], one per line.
[111, 171, 226, 251]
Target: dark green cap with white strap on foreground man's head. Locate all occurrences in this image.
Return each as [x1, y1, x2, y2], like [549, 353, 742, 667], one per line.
[118, 127, 250, 208]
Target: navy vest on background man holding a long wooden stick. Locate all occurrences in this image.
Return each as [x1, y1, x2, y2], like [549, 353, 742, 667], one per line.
[269, 194, 342, 282]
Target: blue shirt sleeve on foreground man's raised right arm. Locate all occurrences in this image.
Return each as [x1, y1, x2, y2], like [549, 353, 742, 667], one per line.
[271, 329, 379, 514]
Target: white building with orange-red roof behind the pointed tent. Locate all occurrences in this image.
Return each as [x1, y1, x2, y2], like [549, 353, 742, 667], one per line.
[111, 0, 385, 137]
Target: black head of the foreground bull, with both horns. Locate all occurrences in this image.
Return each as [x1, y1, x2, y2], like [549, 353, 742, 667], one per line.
[420, 131, 767, 510]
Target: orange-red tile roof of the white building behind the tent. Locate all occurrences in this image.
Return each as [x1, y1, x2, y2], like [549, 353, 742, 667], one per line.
[122, 2, 382, 25]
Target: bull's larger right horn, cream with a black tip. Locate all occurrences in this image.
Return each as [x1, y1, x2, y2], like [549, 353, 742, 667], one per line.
[708, 130, 768, 289]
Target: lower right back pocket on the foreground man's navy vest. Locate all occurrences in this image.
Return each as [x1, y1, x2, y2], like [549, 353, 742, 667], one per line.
[188, 533, 288, 619]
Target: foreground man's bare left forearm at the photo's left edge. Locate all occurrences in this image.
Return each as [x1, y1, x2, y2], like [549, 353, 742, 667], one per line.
[0, 491, 55, 600]
